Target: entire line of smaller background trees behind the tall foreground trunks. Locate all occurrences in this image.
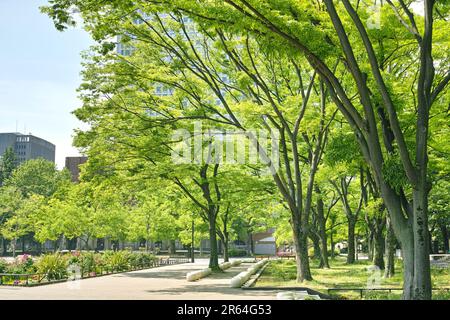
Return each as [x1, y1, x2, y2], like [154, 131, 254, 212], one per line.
[0, 150, 448, 264]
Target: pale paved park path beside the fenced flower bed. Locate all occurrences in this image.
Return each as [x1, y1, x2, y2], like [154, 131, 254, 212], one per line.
[0, 259, 277, 300]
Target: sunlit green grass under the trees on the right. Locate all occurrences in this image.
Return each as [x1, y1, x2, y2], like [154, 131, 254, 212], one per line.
[256, 257, 450, 300]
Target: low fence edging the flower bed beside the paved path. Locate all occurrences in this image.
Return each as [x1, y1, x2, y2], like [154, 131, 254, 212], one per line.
[0, 258, 190, 287]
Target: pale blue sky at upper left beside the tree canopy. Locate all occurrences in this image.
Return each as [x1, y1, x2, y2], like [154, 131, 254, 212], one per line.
[0, 0, 92, 168]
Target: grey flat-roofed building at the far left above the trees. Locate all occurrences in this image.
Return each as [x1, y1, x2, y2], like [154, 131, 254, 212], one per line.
[0, 132, 55, 164]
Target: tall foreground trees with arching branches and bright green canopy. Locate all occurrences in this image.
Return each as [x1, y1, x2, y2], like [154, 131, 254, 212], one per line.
[26, 0, 450, 299]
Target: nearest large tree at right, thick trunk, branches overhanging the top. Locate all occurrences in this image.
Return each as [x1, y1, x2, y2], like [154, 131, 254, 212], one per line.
[45, 0, 450, 299]
